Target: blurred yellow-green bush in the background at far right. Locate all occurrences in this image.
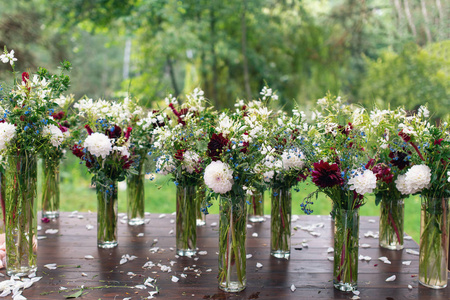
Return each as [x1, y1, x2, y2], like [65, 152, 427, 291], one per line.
[360, 41, 450, 119]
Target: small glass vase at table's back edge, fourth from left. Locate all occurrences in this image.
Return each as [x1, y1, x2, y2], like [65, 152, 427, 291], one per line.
[127, 156, 145, 226]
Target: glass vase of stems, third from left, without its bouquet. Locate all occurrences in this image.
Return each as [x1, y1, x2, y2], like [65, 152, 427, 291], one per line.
[95, 178, 119, 248]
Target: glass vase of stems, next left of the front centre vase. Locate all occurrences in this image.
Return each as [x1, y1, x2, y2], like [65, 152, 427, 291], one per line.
[175, 185, 197, 256]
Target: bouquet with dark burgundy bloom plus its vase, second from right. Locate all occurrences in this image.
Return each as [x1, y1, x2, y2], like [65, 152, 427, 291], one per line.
[370, 108, 411, 250]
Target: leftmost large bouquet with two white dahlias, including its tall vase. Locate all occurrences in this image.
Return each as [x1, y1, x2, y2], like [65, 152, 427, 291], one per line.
[0, 48, 70, 275]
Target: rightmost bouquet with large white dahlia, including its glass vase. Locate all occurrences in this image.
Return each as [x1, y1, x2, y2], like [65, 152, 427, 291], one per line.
[388, 106, 450, 288]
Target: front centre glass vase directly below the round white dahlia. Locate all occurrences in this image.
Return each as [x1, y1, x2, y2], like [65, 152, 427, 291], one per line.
[218, 196, 247, 293]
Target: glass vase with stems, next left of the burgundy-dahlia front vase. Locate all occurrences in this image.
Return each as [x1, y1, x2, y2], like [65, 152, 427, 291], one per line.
[270, 189, 292, 259]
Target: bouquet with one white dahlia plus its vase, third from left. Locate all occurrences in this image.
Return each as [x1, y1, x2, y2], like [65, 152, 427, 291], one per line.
[72, 99, 134, 248]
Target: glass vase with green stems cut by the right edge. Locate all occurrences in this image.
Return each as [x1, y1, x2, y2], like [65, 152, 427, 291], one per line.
[419, 197, 450, 289]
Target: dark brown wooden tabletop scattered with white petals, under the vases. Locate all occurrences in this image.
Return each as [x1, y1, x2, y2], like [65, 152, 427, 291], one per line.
[7, 213, 450, 300]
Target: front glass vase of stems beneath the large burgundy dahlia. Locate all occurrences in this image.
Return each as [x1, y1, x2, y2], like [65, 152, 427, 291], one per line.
[333, 209, 359, 292]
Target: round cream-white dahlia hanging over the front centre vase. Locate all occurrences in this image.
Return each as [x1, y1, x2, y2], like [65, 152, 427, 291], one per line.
[204, 161, 234, 194]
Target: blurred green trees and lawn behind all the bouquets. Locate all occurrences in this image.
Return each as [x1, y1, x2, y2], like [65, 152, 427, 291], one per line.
[0, 0, 450, 241]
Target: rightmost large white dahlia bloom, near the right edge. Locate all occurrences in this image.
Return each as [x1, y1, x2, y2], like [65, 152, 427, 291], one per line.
[395, 165, 431, 195]
